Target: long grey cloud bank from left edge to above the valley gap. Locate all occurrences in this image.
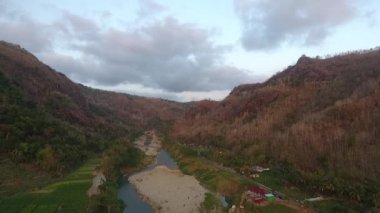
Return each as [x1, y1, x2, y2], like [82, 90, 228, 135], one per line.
[0, 0, 255, 98]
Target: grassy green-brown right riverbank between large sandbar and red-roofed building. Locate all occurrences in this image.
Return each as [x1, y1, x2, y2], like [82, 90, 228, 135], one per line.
[163, 141, 308, 212]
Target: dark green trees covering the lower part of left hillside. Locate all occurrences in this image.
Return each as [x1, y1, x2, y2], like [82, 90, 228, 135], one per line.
[0, 72, 132, 176]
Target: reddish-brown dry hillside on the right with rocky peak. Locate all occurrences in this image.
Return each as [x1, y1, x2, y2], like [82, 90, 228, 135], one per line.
[172, 49, 380, 205]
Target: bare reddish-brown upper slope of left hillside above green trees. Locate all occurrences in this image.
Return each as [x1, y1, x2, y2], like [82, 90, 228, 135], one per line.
[0, 42, 184, 127]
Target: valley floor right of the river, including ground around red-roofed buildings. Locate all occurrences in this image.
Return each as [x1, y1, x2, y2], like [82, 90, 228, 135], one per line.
[164, 141, 361, 212]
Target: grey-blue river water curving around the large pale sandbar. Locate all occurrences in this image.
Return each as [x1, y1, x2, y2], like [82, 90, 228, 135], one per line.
[118, 150, 178, 213]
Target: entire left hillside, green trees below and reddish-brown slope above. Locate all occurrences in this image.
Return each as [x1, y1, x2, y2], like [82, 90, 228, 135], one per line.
[0, 42, 185, 196]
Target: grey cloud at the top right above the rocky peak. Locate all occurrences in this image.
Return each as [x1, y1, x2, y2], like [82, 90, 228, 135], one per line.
[234, 0, 356, 50]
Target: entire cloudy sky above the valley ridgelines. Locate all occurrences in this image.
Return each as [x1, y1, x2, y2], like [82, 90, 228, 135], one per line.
[0, 0, 380, 101]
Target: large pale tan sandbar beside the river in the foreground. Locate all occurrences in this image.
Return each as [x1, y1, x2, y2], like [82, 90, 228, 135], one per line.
[129, 166, 207, 213]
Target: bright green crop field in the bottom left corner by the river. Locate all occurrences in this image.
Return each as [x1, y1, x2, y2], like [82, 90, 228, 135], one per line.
[0, 159, 100, 213]
